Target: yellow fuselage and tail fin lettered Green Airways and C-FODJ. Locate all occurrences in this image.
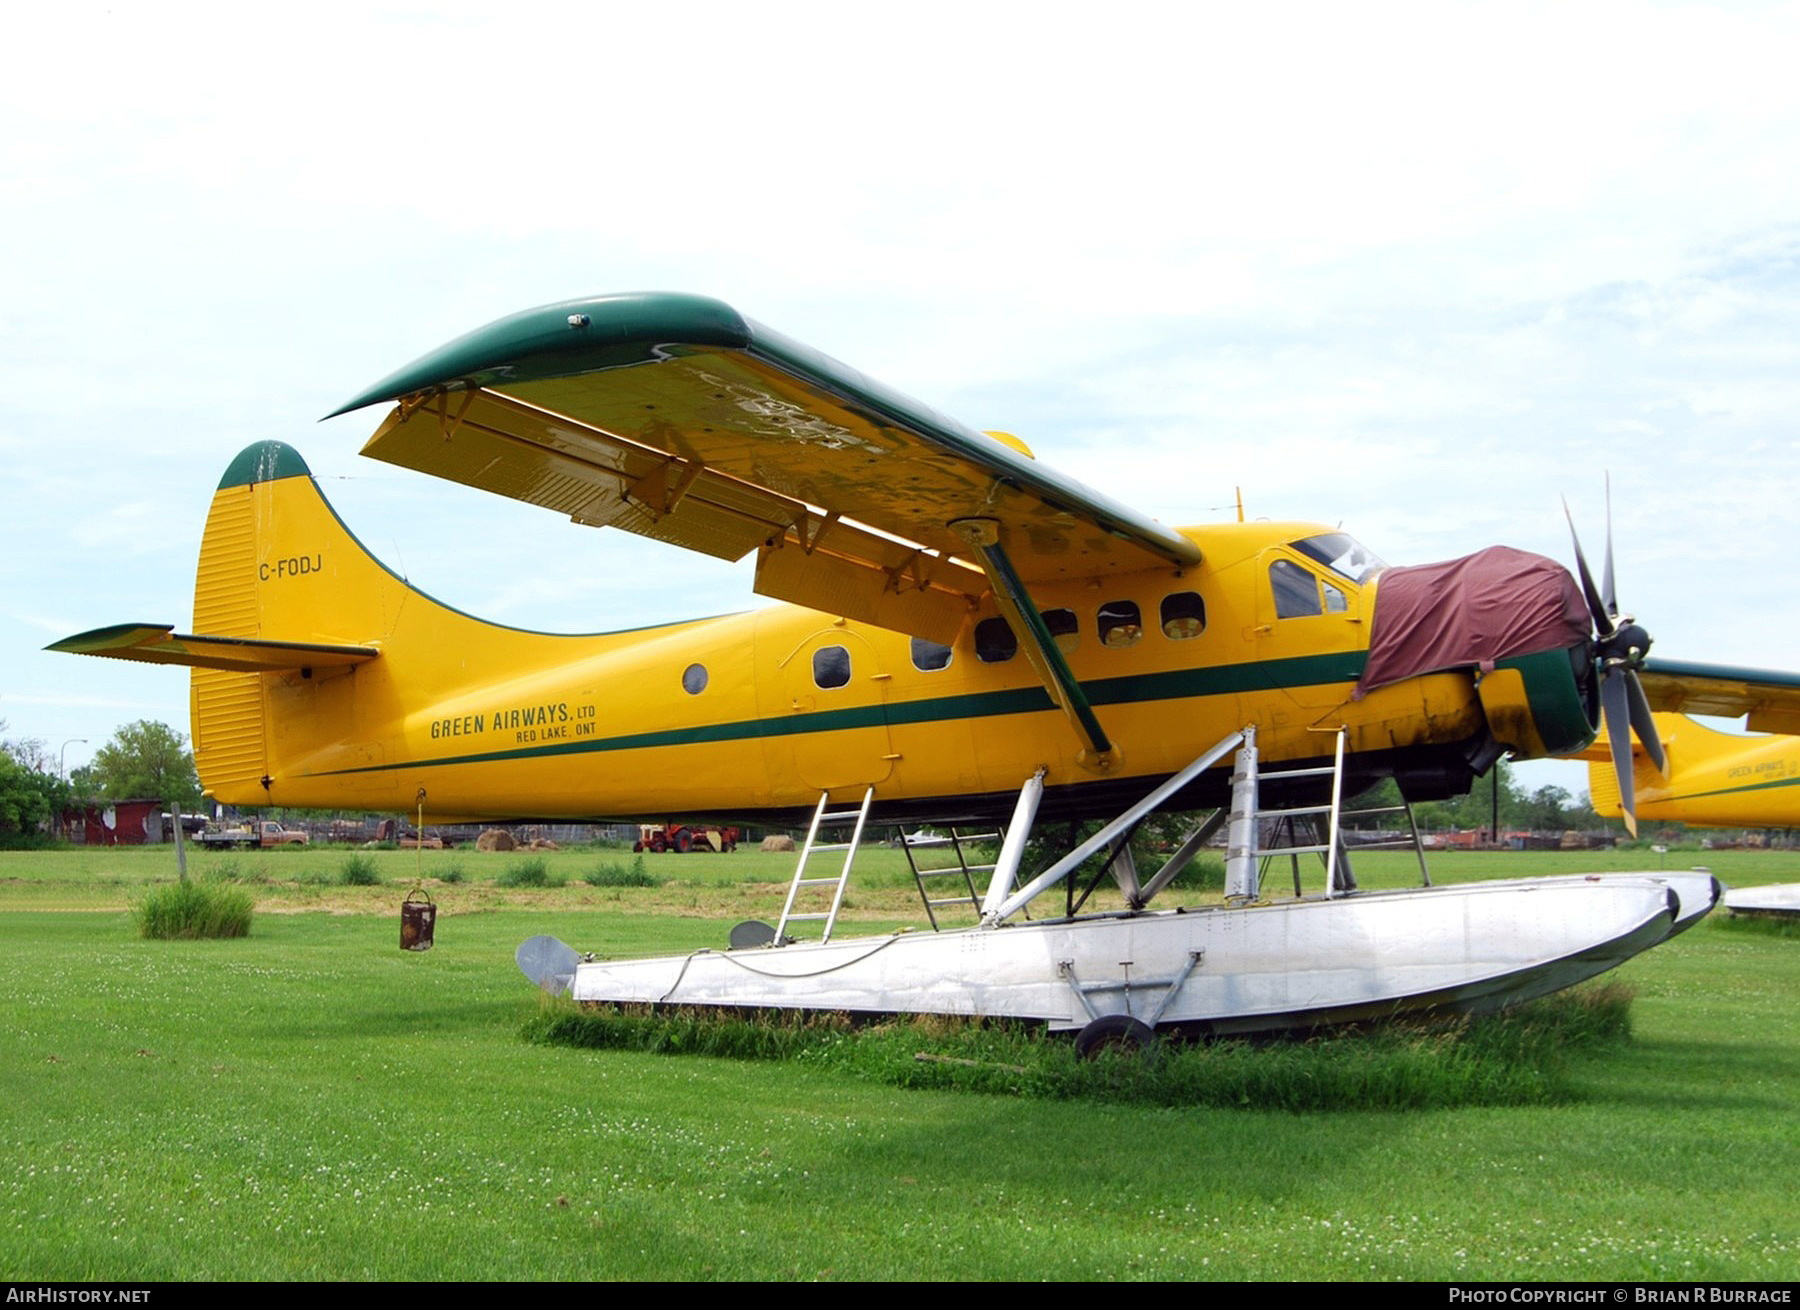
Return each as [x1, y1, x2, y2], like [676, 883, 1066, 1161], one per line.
[193, 460, 1485, 819]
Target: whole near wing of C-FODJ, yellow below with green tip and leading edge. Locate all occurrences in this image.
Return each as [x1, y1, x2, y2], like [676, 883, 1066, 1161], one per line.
[337, 293, 1199, 597]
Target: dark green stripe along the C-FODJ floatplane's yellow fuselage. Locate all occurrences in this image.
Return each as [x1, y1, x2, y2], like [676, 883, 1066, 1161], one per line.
[304, 651, 1366, 777]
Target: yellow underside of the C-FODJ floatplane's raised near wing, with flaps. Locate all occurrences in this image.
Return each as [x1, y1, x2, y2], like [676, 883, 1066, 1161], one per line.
[364, 349, 1197, 642]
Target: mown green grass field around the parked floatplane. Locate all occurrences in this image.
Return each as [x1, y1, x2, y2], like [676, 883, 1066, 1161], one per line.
[0, 849, 1800, 1281]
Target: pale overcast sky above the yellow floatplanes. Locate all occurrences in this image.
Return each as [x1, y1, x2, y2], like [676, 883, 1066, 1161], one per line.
[0, 0, 1800, 809]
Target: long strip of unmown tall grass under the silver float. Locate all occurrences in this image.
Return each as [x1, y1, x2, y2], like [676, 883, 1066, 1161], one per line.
[524, 984, 1631, 1114]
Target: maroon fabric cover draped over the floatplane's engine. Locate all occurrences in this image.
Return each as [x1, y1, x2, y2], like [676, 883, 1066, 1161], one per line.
[1357, 545, 1589, 696]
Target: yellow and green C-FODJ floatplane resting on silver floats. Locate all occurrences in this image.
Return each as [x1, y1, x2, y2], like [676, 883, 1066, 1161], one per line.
[56, 293, 1800, 1029]
